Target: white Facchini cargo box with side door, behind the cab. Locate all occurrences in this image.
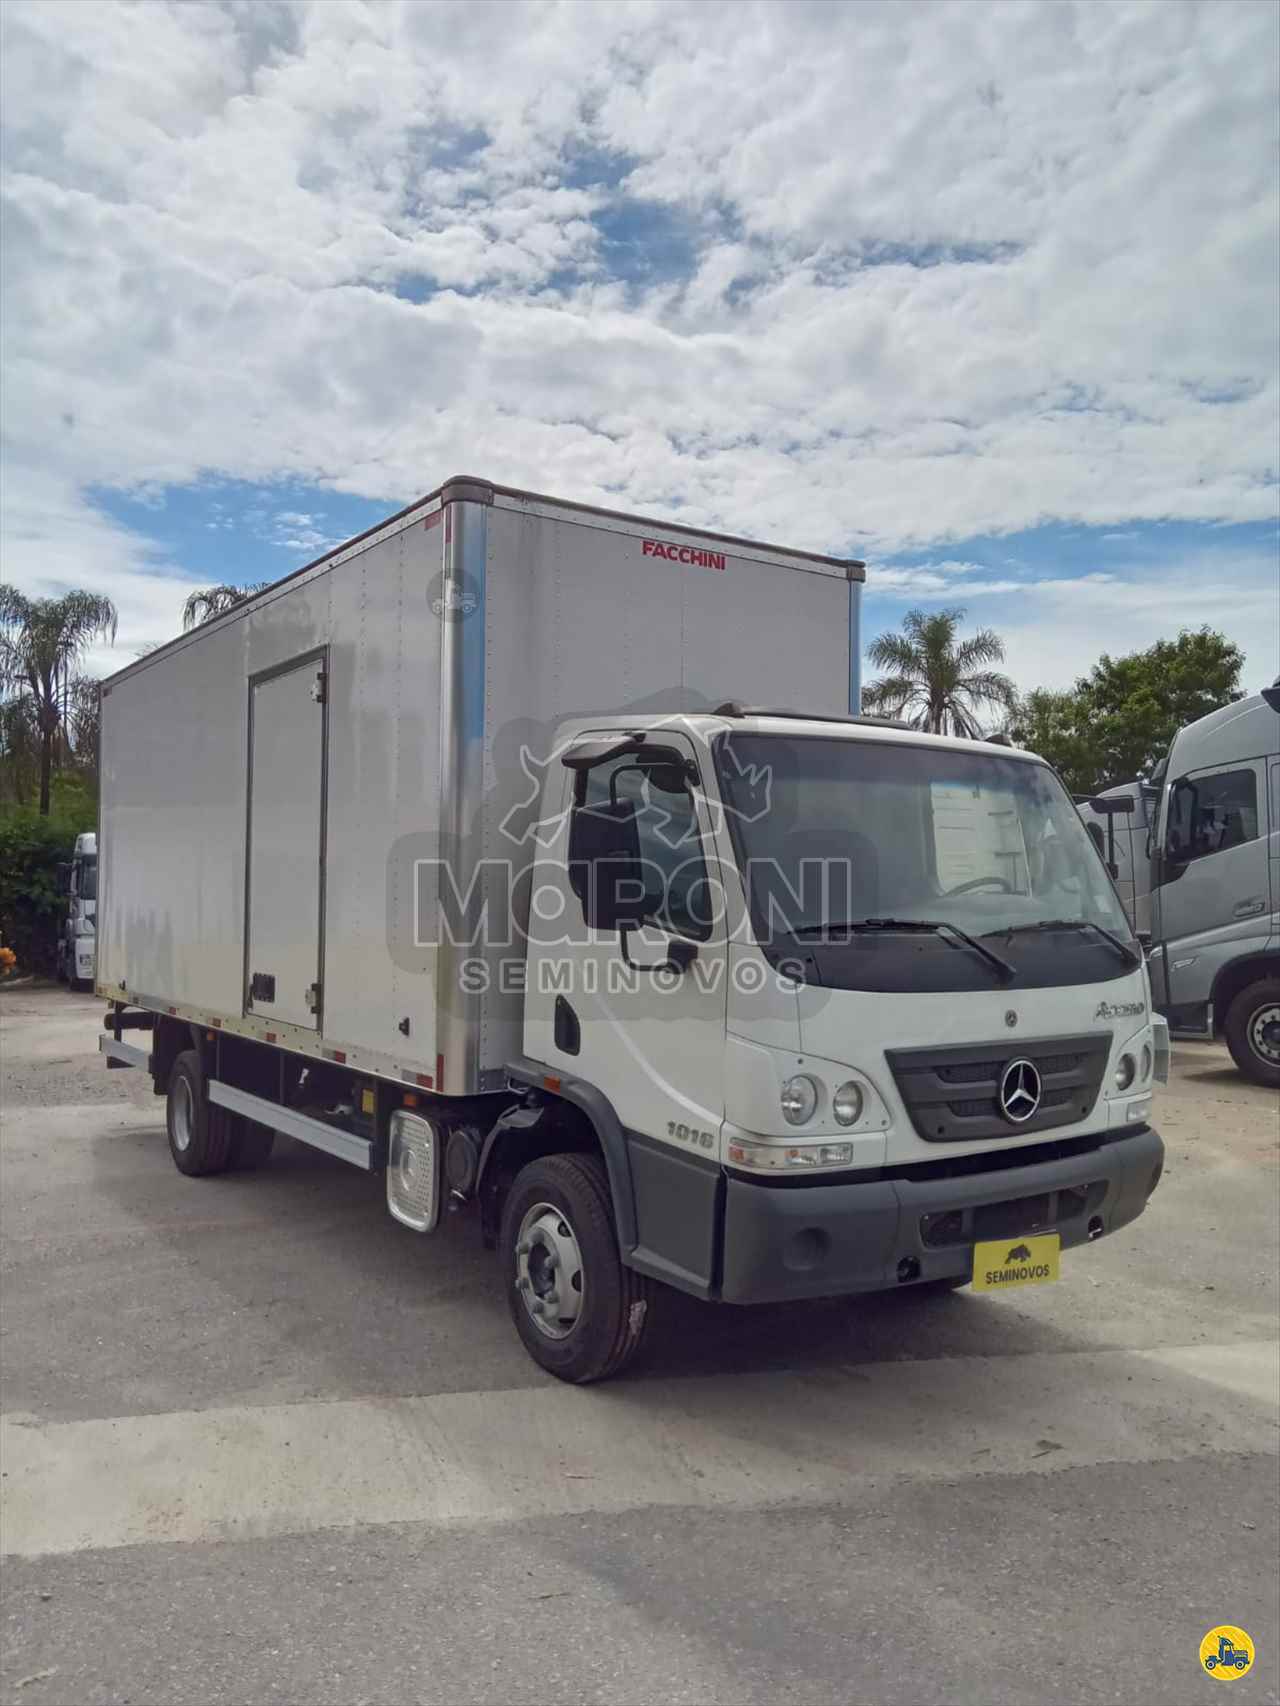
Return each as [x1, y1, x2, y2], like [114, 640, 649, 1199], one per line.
[97, 479, 862, 1095]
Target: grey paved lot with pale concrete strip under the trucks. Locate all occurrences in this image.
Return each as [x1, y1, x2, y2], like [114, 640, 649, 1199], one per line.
[0, 989, 1280, 1706]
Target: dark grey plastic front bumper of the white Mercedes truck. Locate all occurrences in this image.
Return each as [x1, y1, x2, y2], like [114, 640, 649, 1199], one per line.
[720, 1126, 1164, 1303]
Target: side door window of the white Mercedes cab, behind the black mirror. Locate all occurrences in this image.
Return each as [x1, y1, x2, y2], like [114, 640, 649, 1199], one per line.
[575, 754, 712, 942]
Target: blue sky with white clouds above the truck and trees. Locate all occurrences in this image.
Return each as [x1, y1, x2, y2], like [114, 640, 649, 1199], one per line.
[0, 0, 1280, 688]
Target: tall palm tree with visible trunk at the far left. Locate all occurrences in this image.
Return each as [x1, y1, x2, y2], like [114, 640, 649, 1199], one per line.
[0, 585, 118, 817]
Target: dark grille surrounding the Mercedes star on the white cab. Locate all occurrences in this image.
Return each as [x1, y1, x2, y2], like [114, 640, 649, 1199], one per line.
[887, 1032, 1111, 1139]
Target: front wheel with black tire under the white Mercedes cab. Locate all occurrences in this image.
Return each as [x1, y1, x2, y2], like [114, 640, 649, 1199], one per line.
[498, 1155, 649, 1385]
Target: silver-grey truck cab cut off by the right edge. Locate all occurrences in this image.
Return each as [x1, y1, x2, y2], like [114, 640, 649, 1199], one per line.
[1149, 684, 1280, 1087]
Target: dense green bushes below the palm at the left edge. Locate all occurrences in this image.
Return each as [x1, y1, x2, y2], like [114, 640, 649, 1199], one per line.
[0, 771, 97, 974]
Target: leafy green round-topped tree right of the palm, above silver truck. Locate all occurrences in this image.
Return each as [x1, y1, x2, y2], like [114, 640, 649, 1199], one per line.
[1007, 628, 1244, 793]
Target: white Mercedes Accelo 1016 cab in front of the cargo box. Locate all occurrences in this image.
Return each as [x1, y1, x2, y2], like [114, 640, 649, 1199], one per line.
[488, 706, 1167, 1353]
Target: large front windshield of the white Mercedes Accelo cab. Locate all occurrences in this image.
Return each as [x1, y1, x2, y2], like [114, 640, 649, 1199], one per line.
[717, 734, 1133, 988]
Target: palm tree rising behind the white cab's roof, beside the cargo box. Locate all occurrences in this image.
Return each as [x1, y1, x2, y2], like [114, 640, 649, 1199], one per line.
[862, 611, 1017, 739]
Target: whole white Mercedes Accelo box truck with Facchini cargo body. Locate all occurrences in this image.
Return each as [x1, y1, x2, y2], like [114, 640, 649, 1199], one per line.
[97, 478, 1167, 1382]
